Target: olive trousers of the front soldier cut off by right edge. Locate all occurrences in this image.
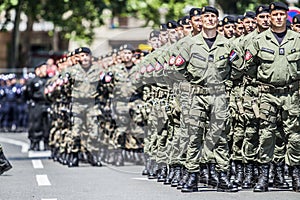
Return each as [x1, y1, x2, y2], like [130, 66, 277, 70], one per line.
[258, 91, 300, 166]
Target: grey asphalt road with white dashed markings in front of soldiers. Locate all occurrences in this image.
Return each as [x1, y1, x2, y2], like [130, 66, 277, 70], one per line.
[0, 133, 300, 200]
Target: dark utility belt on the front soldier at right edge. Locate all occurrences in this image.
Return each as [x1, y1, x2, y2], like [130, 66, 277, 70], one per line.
[258, 81, 299, 94]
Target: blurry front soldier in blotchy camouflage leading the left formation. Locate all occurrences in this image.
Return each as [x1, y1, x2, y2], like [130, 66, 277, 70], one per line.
[65, 47, 102, 167]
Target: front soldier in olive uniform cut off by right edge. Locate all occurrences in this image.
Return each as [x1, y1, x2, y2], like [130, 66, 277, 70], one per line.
[244, 2, 300, 192]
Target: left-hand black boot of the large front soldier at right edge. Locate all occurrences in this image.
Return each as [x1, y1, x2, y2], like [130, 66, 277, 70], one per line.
[253, 164, 270, 192]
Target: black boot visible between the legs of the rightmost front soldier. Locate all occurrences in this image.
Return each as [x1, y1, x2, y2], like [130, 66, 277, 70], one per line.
[273, 162, 290, 189]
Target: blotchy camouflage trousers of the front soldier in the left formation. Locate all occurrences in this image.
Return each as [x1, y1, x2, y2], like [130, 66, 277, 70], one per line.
[68, 102, 100, 152]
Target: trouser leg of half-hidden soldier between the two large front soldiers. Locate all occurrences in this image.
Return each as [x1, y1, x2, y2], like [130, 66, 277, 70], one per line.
[242, 85, 259, 163]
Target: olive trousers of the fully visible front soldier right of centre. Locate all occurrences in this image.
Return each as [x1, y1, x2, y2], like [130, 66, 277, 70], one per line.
[186, 92, 229, 172]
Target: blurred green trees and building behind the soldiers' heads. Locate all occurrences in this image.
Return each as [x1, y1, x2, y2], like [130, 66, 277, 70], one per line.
[0, 0, 299, 73]
